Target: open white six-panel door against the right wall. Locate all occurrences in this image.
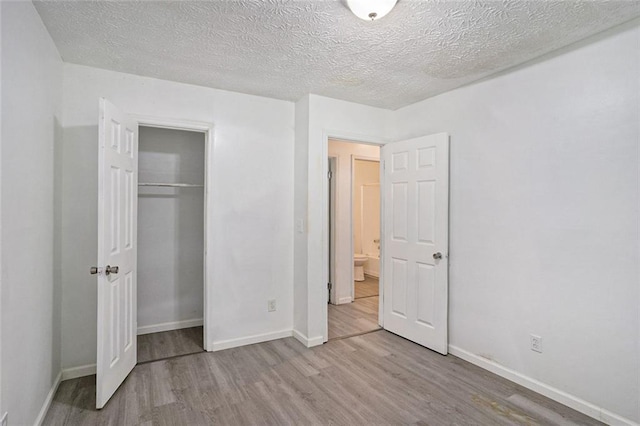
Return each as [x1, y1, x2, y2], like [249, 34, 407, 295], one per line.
[382, 133, 449, 355]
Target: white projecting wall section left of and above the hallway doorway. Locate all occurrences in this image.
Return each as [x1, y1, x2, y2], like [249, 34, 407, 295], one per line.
[294, 95, 392, 346]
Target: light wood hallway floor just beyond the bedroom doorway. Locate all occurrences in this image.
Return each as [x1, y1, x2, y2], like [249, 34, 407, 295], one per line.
[328, 296, 380, 339]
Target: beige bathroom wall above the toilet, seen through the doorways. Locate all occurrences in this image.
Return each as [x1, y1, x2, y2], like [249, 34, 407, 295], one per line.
[353, 159, 380, 254]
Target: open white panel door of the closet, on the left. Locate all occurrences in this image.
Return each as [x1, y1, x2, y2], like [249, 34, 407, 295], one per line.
[92, 99, 138, 408]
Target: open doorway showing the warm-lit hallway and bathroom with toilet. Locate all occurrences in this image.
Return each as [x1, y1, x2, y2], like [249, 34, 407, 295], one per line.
[327, 139, 381, 339]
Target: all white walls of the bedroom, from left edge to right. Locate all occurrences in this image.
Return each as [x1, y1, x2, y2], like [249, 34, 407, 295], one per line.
[0, 2, 640, 424]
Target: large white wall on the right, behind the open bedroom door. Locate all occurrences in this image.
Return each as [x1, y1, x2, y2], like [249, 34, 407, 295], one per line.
[396, 20, 640, 422]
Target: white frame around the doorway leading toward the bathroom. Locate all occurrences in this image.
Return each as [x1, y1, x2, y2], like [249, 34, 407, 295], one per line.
[320, 130, 389, 342]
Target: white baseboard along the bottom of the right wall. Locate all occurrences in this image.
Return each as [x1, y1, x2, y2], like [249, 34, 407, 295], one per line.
[449, 345, 638, 426]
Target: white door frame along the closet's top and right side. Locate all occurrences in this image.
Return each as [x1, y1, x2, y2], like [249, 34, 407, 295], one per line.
[127, 114, 214, 352]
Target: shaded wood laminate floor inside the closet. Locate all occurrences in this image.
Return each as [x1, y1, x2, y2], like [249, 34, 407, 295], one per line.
[138, 327, 204, 363]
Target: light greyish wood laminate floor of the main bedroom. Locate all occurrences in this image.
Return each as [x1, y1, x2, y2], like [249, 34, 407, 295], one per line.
[44, 331, 600, 426]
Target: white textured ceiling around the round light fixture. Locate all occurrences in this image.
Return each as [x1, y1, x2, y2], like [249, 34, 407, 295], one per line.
[35, 0, 640, 109]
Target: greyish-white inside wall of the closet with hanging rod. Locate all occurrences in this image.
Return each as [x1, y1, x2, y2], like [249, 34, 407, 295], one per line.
[138, 127, 205, 331]
